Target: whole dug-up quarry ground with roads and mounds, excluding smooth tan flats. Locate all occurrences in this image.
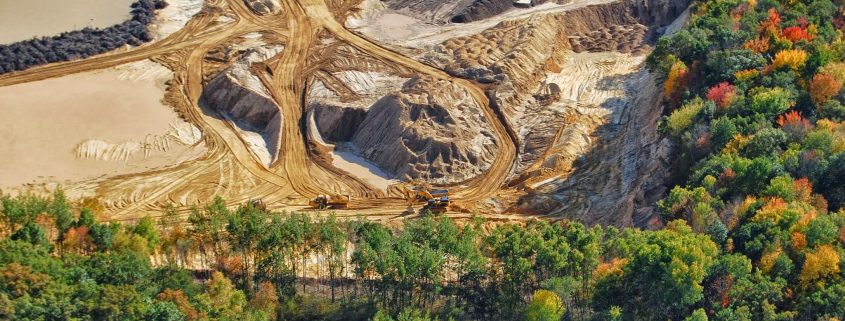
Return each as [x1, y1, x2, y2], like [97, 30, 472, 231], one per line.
[0, 0, 689, 226]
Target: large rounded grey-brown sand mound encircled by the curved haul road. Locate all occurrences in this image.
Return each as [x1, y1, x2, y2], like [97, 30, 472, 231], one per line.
[352, 78, 498, 183]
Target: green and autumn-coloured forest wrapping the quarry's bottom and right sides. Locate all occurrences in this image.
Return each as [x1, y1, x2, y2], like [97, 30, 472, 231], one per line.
[0, 0, 845, 321]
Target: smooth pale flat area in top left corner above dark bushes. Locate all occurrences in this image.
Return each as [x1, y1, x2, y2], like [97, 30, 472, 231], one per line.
[0, 0, 133, 44]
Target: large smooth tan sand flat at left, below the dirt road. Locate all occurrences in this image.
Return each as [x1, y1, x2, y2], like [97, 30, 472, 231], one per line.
[0, 61, 199, 189]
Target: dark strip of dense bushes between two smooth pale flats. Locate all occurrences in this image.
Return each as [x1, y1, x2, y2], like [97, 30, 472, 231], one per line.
[0, 0, 167, 74]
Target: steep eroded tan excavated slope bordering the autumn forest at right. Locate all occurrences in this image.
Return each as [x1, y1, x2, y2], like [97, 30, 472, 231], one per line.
[398, 0, 689, 226]
